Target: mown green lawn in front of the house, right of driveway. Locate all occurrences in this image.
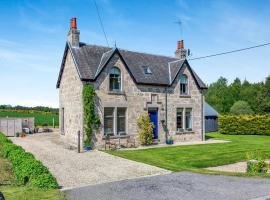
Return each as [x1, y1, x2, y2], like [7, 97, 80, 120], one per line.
[108, 133, 270, 172]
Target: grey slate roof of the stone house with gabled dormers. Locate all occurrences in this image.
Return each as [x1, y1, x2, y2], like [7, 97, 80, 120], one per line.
[57, 43, 207, 89]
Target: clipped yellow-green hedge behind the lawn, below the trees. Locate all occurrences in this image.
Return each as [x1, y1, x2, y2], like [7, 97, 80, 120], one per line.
[218, 115, 270, 135]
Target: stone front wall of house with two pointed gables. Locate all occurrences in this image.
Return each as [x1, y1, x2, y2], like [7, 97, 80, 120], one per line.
[94, 55, 202, 147]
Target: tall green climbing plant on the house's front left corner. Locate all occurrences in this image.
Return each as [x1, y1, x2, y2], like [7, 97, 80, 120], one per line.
[83, 83, 100, 146]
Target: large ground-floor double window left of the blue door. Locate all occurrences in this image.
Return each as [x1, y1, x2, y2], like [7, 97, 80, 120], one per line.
[104, 107, 127, 136]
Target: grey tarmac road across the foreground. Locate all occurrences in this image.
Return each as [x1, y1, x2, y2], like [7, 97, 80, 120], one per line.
[66, 172, 270, 200]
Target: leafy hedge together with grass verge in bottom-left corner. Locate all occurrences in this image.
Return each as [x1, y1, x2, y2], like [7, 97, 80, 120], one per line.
[0, 133, 64, 200]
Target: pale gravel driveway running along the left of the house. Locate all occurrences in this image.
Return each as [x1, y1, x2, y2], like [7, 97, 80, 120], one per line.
[11, 133, 170, 189]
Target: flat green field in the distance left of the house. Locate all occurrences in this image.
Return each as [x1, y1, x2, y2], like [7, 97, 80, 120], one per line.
[0, 110, 59, 126]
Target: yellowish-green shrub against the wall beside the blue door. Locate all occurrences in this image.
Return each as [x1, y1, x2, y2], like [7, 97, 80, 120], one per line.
[137, 113, 154, 145]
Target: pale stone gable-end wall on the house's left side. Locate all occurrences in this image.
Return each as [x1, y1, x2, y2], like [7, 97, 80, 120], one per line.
[59, 50, 83, 146]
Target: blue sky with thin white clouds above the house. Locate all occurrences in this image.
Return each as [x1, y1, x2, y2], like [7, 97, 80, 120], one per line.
[0, 0, 270, 107]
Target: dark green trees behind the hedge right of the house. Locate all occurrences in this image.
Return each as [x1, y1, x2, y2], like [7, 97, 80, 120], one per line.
[205, 75, 270, 114]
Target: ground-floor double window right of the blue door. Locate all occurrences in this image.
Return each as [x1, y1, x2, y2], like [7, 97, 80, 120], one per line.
[176, 108, 193, 132]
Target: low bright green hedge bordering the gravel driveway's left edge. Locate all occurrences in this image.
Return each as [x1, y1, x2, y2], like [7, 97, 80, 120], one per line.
[0, 133, 58, 188]
